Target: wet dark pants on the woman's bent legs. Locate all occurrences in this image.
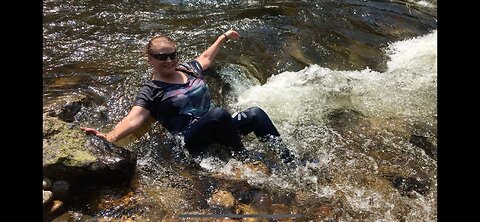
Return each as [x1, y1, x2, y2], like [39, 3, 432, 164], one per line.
[183, 107, 280, 151]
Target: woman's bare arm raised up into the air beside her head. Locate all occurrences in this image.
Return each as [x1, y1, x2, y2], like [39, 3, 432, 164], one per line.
[197, 29, 240, 70]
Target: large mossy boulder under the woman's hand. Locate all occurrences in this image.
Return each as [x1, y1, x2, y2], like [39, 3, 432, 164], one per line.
[43, 115, 137, 190]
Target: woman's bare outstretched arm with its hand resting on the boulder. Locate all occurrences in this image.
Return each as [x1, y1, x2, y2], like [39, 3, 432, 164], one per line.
[80, 106, 150, 143]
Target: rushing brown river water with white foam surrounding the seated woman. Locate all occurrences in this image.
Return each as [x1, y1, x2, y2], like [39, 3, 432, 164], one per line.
[43, 0, 437, 221]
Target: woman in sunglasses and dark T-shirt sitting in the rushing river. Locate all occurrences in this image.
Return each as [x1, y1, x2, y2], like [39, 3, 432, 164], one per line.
[81, 30, 292, 159]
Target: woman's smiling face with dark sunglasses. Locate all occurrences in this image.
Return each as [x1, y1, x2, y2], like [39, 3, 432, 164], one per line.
[148, 41, 178, 74]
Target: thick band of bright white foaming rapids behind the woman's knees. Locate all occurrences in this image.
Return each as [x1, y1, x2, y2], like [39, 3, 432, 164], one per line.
[228, 31, 437, 126]
